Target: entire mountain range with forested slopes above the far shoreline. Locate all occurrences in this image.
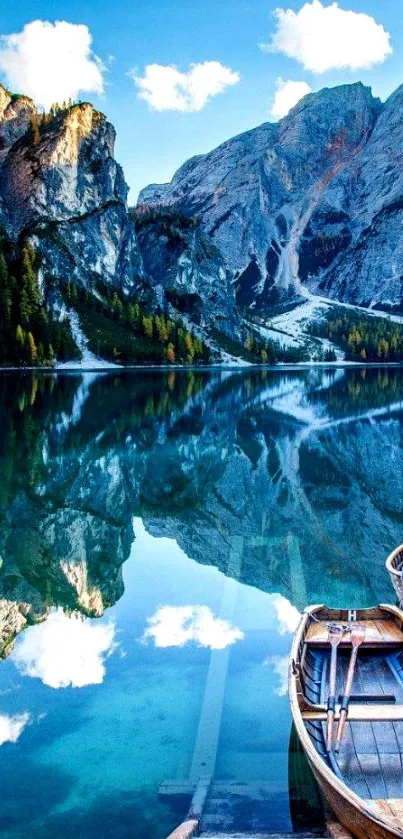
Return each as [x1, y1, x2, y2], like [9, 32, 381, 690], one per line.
[0, 83, 403, 363]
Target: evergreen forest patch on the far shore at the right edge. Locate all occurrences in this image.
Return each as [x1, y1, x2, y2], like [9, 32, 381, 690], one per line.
[312, 310, 403, 363]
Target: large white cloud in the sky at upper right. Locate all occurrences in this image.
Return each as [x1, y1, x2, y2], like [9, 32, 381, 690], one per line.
[261, 0, 392, 73]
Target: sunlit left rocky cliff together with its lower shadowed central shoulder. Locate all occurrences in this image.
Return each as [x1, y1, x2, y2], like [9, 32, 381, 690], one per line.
[0, 80, 240, 356]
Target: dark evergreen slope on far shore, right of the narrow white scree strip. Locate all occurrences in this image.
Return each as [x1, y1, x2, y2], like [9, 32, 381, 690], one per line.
[65, 283, 211, 364]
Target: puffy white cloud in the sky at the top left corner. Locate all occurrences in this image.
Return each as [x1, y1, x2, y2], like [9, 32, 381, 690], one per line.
[0, 20, 103, 108]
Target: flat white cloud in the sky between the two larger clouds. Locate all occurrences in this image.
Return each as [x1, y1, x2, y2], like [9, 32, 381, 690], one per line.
[129, 61, 240, 111]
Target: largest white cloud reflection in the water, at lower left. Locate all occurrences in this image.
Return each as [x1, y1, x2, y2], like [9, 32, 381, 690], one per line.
[12, 610, 116, 688]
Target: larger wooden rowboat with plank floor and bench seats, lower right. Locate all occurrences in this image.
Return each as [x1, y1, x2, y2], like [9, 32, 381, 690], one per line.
[289, 605, 403, 839]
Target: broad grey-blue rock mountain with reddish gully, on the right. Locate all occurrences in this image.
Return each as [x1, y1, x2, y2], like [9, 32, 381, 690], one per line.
[139, 83, 403, 309]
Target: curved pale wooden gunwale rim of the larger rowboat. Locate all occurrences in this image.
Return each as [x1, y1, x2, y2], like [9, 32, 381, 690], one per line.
[288, 604, 403, 839]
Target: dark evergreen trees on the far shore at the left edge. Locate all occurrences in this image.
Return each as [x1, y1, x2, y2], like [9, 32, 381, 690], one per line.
[0, 235, 80, 366]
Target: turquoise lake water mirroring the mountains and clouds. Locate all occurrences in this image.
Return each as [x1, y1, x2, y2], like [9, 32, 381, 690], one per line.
[0, 369, 403, 839]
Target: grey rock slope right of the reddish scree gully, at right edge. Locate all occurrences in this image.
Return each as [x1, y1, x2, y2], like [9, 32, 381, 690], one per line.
[310, 86, 403, 308]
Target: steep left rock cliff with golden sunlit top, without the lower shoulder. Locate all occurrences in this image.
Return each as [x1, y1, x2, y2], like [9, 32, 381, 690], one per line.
[0, 89, 141, 288]
